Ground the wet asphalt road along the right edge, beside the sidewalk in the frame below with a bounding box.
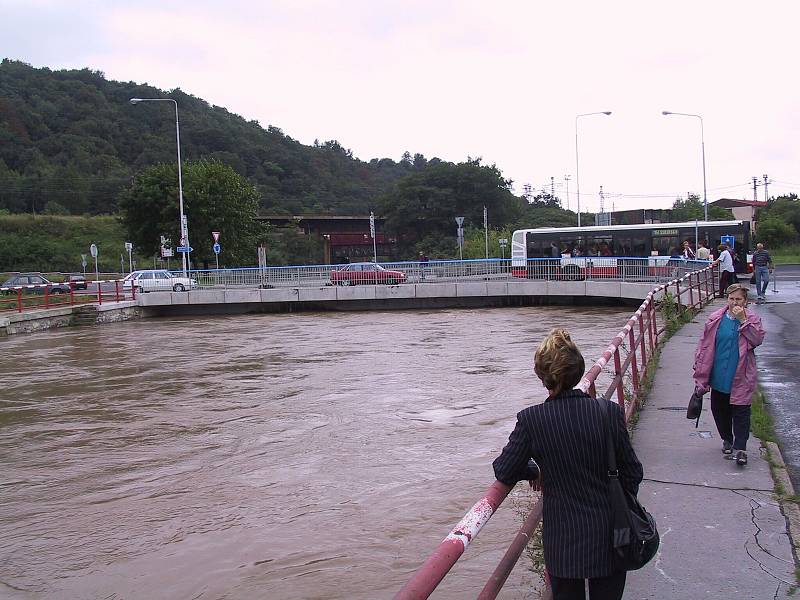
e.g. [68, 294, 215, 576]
[753, 265, 800, 490]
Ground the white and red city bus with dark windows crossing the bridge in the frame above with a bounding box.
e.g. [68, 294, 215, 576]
[511, 221, 750, 280]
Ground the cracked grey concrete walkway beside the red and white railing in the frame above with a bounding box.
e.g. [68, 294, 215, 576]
[624, 300, 800, 600]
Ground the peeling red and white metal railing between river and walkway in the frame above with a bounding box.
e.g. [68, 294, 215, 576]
[394, 266, 718, 600]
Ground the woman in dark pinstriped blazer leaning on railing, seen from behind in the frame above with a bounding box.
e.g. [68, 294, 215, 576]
[492, 329, 644, 600]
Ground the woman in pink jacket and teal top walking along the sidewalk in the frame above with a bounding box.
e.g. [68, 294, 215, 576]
[694, 283, 764, 465]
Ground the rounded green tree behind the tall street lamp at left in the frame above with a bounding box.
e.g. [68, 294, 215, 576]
[119, 160, 266, 266]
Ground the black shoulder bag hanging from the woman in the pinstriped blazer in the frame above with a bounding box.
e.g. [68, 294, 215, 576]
[599, 399, 661, 571]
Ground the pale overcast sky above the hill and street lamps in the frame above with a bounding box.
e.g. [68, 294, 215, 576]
[0, 0, 800, 211]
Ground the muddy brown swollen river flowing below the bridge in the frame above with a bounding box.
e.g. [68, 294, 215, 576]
[0, 307, 630, 600]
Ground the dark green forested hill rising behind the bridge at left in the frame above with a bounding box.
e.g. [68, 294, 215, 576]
[0, 59, 424, 214]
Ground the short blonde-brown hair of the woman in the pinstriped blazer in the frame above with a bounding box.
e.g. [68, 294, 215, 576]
[533, 329, 586, 396]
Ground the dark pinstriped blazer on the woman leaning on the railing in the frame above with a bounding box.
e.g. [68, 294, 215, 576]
[493, 390, 643, 579]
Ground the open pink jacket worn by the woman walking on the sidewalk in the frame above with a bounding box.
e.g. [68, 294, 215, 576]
[694, 306, 764, 405]
